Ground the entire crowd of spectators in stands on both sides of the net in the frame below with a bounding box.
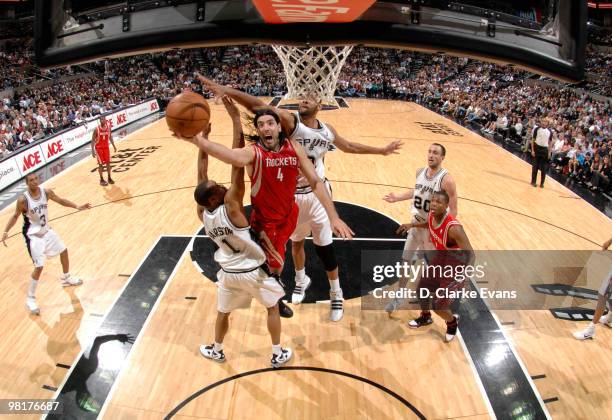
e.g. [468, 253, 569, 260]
[0, 42, 612, 196]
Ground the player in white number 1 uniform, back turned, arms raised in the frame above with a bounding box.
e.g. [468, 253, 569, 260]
[186, 97, 292, 367]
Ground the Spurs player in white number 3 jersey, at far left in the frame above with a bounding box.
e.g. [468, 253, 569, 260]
[2, 173, 91, 315]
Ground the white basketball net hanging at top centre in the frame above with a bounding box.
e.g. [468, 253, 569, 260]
[272, 45, 353, 105]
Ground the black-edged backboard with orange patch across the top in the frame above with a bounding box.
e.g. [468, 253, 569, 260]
[35, 0, 587, 82]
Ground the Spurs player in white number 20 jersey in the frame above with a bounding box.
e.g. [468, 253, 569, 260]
[383, 143, 457, 313]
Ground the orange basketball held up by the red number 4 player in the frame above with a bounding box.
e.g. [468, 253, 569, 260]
[166, 92, 210, 137]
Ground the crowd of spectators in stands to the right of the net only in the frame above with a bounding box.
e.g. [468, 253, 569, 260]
[336, 48, 612, 192]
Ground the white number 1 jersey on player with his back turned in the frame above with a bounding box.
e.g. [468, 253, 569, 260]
[202, 205, 266, 273]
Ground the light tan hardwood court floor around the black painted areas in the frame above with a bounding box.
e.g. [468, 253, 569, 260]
[0, 100, 612, 419]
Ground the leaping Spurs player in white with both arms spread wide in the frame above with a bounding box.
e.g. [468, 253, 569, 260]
[198, 76, 402, 321]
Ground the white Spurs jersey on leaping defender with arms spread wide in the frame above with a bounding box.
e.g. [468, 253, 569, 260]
[289, 114, 335, 189]
